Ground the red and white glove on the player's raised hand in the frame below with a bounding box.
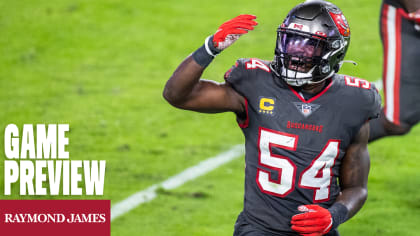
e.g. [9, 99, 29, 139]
[213, 15, 257, 50]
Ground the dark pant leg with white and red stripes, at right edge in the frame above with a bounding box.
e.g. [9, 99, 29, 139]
[381, 0, 420, 125]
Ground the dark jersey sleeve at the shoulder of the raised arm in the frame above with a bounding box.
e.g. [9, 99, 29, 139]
[224, 58, 249, 96]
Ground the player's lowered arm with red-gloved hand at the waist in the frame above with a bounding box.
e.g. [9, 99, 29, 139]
[291, 122, 370, 236]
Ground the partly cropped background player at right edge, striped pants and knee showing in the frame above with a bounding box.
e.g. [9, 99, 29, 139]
[369, 0, 420, 141]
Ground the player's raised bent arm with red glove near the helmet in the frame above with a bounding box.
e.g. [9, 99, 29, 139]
[163, 15, 257, 114]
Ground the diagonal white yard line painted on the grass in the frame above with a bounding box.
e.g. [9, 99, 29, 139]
[111, 144, 245, 221]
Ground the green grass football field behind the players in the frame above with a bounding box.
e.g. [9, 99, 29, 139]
[0, 0, 420, 236]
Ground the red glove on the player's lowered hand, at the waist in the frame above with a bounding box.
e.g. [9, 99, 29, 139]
[291, 205, 332, 236]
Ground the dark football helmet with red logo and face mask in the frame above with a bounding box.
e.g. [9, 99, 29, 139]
[271, 0, 350, 86]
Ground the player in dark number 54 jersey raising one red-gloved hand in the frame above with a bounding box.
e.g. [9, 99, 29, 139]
[163, 1, 380, 236]
